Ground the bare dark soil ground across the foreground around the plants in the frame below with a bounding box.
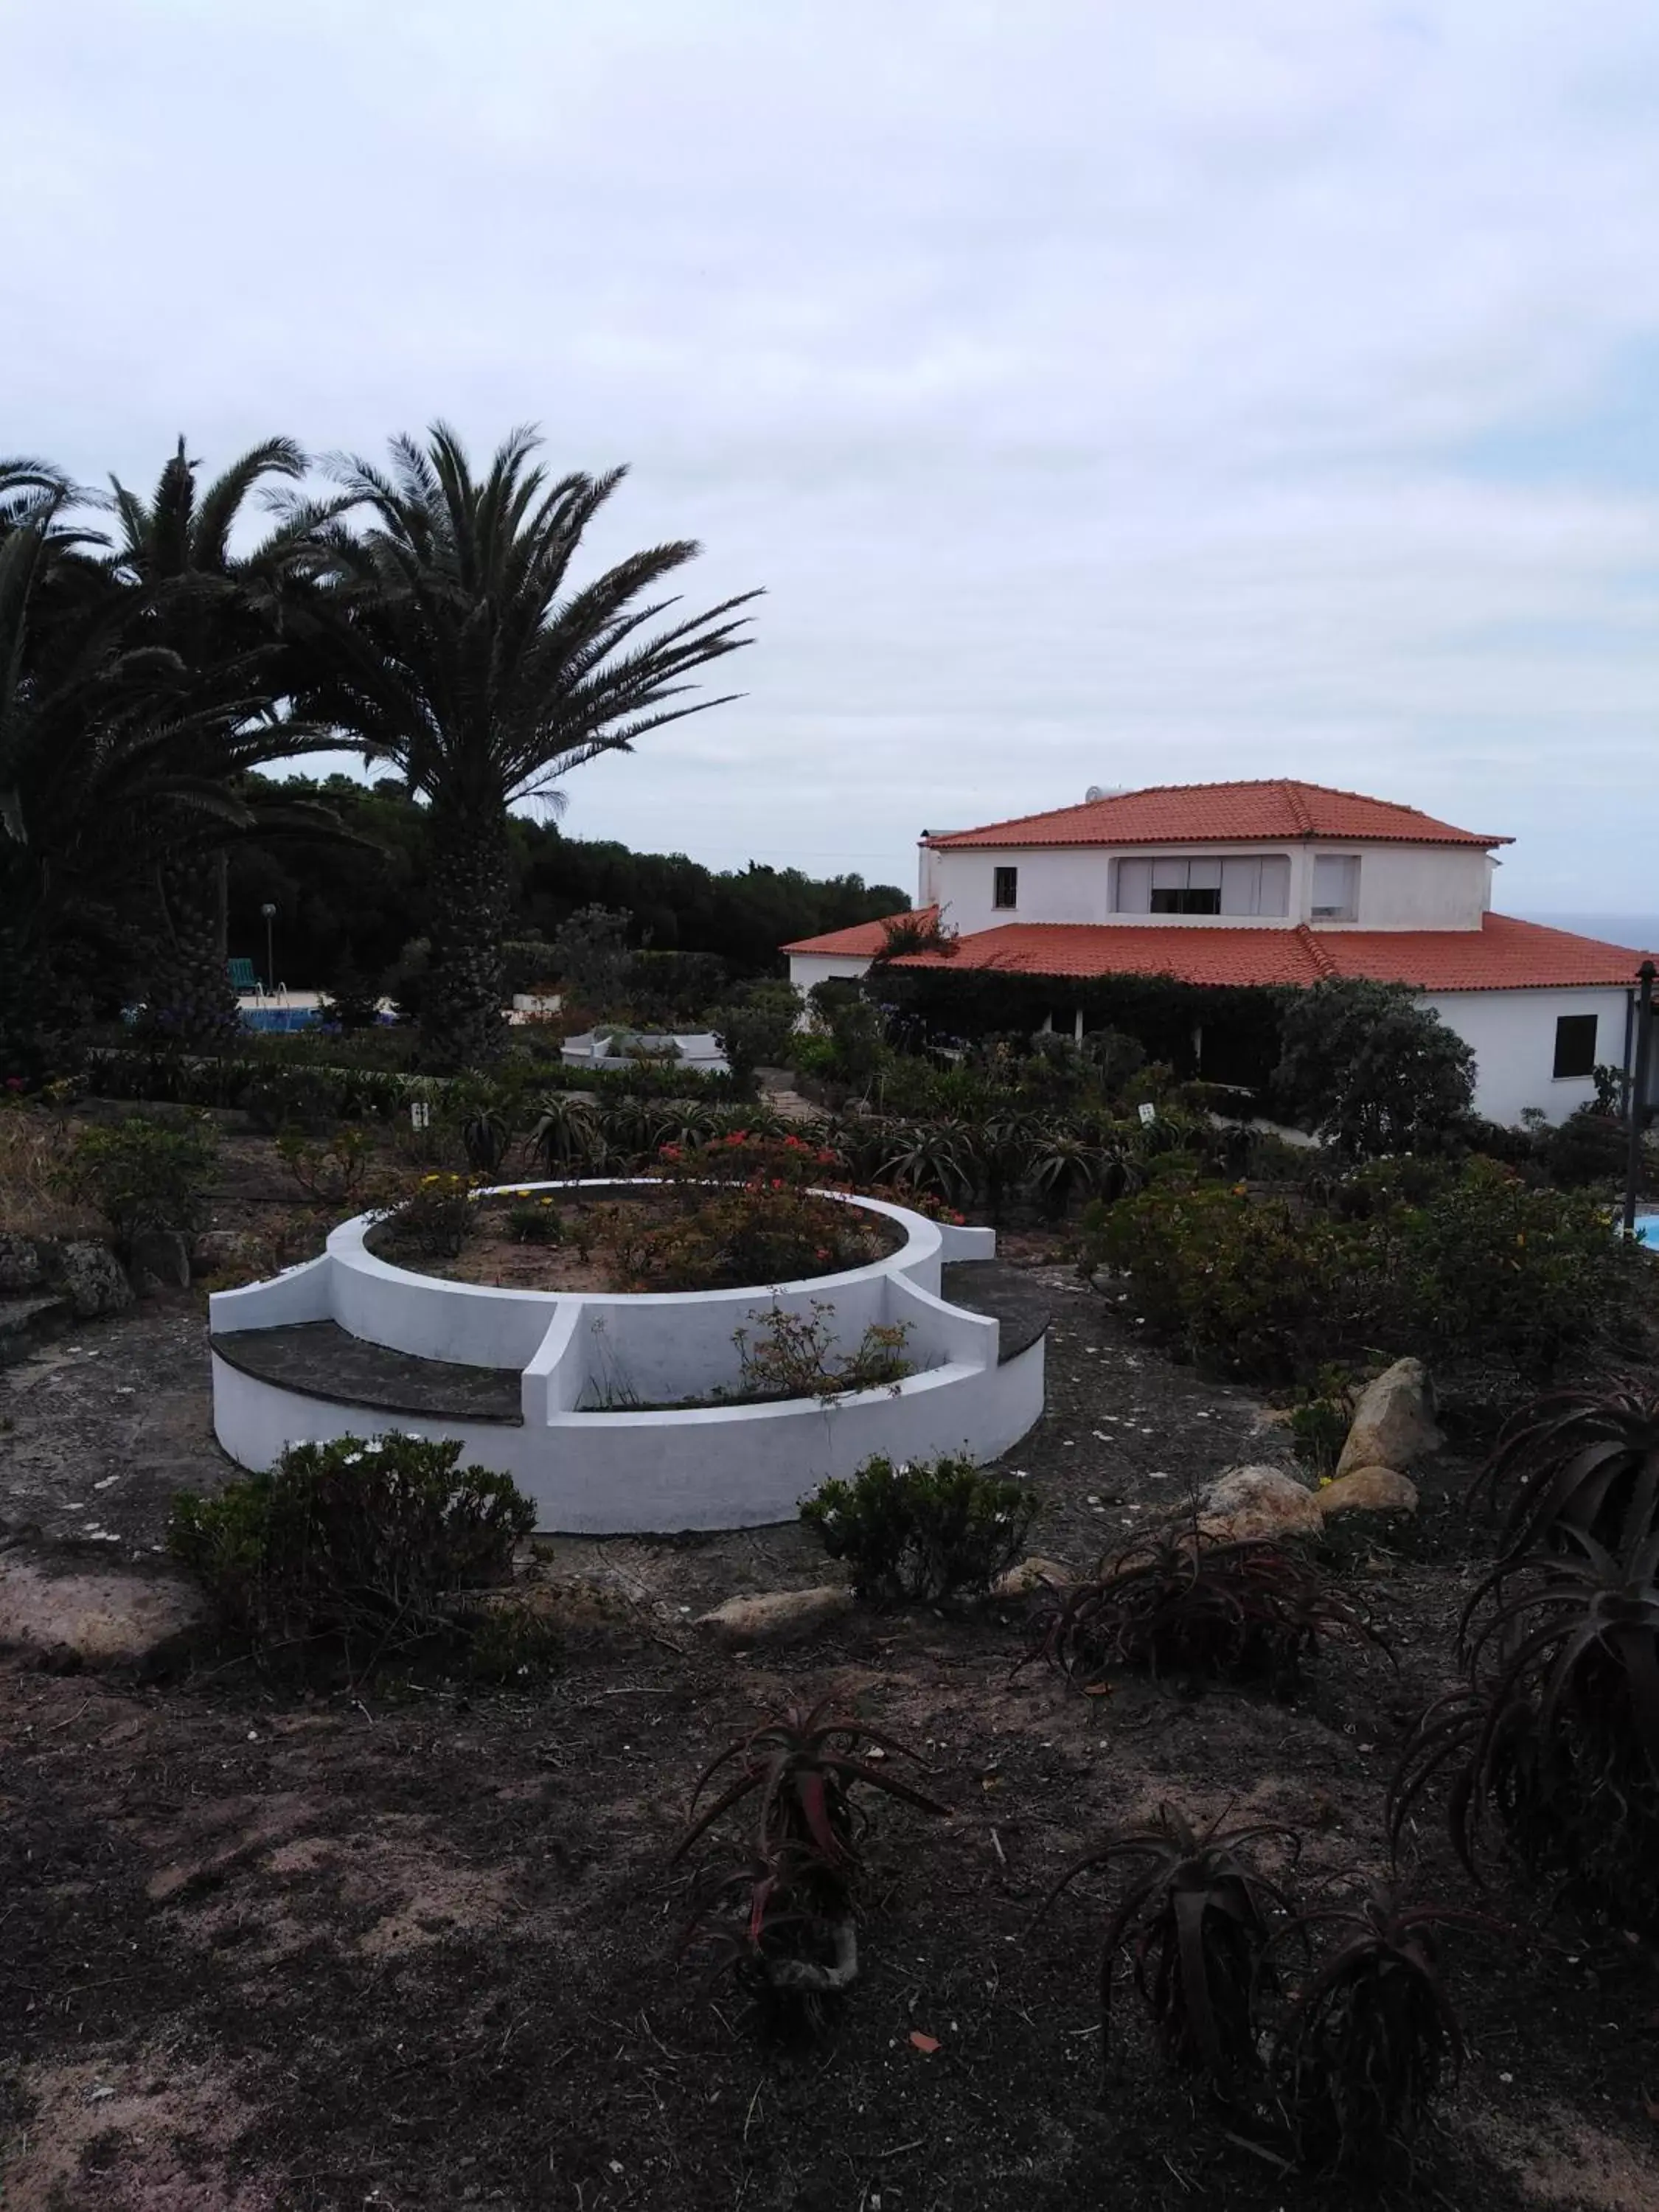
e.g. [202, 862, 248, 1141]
[0, 1239, 1659, 2212]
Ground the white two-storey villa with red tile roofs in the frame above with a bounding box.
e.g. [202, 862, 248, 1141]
[783, 781, 1652, 1124]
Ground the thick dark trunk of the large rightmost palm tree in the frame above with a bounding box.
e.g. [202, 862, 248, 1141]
[420, 799, 511, 1071]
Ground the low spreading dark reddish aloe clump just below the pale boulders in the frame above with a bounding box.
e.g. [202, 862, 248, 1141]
[1033, 1528, 1385, 1688]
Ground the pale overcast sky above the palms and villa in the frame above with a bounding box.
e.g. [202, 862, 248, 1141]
[0, 0, 1659, 914]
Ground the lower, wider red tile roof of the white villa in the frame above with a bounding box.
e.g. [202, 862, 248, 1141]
[876, 914, 1646, 991]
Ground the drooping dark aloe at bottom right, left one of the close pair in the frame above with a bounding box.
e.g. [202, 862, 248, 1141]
[1042, 1807, 1296, 2099]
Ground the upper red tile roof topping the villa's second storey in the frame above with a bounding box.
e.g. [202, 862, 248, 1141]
[922, 779, 1513, 852]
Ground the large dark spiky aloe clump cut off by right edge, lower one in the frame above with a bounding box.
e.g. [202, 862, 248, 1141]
[1389, 1522, 1659, 1935]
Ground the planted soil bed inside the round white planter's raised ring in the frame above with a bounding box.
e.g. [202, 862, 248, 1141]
[367, 1183, 905, 1294]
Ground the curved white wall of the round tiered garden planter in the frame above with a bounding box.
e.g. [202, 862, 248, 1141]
[210, 1183, 1044, 1535]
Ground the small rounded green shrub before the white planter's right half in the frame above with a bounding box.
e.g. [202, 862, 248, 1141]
[801, 1455, 1037, 1599]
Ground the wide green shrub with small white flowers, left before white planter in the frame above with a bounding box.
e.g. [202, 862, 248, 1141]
[168, 1431, 535, 1657]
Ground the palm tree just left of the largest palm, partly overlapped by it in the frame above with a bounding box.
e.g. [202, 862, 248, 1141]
[108, 438, 334, 1044]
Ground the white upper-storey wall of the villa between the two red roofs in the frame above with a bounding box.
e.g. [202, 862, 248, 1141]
[938, 843, 1491, 936]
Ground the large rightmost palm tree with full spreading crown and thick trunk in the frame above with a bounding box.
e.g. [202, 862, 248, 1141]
[305, 422, 759, 1066]
